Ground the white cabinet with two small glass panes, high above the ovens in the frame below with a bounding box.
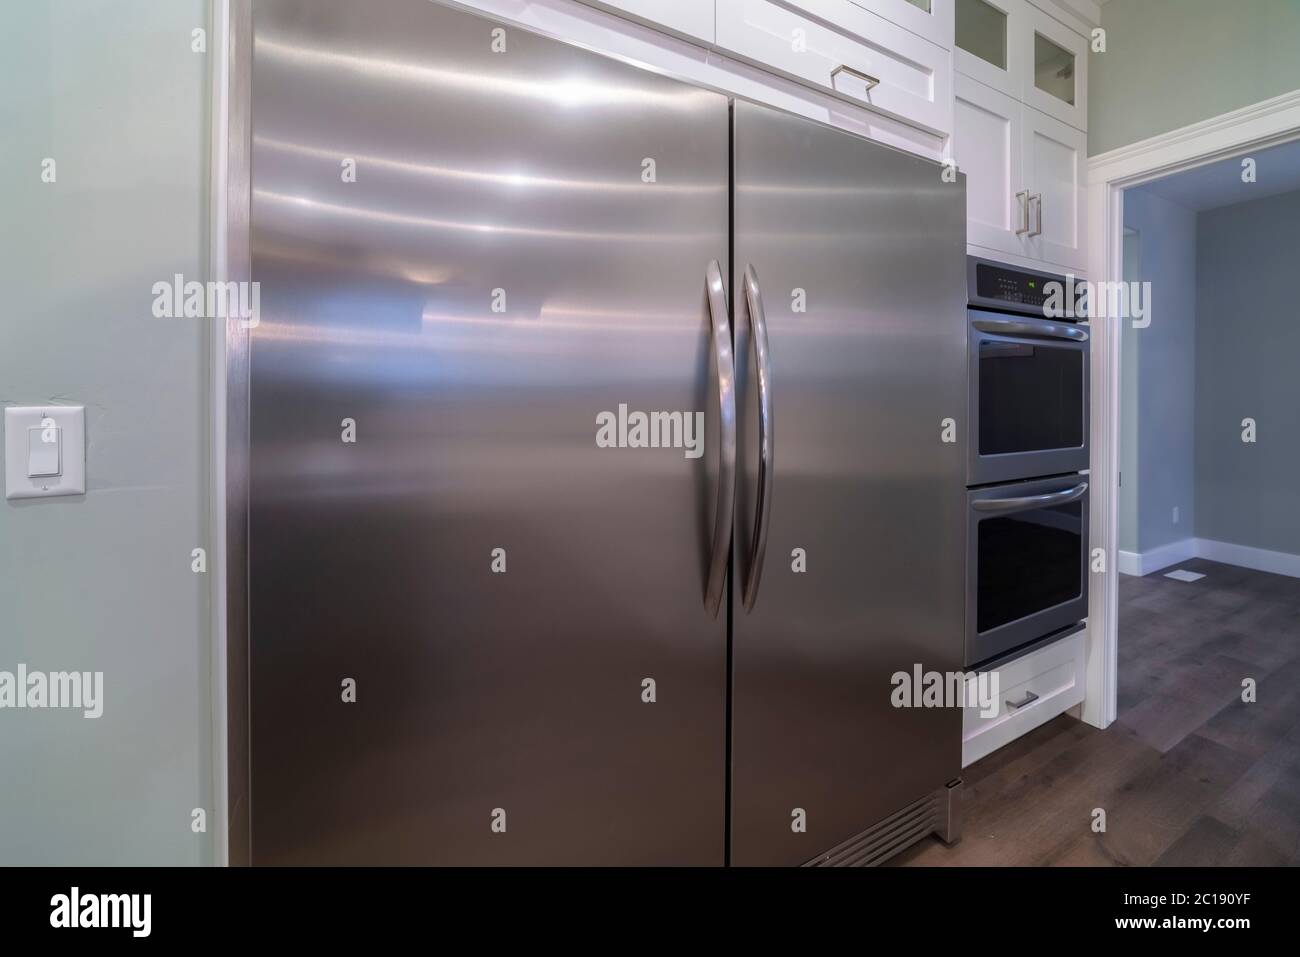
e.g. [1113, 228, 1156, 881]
[953, 0, 1088, 130]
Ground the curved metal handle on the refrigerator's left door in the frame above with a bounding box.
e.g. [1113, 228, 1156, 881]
[705, 259, 736, 618]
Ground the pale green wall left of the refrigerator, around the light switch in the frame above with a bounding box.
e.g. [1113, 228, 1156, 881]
[0, 0, 213, 865]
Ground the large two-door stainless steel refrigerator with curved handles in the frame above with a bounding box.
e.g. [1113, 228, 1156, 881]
[248, 0, 966, 865]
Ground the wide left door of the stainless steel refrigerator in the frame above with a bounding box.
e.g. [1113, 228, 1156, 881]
[250, 0, 729, 865]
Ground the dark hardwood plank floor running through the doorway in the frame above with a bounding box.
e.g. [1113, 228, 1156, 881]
[893, 559, 1300, 865]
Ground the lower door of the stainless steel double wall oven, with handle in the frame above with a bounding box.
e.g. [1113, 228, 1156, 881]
[966, 475, 1088, 666]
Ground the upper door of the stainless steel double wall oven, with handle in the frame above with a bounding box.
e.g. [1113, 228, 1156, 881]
[966, 309, 1088, 485]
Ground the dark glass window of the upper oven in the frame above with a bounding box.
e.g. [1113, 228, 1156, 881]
[979, 341, 1083, 455]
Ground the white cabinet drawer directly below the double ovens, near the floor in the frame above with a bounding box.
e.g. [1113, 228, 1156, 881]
[962, 632, 1086, 767]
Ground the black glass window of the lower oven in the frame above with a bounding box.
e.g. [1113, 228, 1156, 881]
[975, 502, 1083, 633]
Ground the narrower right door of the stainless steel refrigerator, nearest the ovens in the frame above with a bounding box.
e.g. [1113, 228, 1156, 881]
[731, 100, 966, 865]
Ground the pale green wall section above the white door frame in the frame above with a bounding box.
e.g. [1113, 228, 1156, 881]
[1088, 0, 1300, 156]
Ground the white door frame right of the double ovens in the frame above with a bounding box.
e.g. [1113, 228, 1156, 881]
[1080, 90, 1300, 728]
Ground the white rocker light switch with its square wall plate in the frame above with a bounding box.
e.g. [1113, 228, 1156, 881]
[4, 406, 86, 499]
